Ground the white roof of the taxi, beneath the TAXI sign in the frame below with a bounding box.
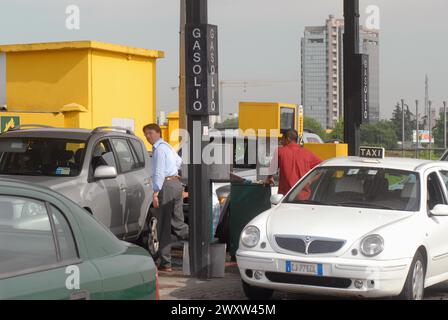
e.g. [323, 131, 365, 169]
[322, 157, 448, 172]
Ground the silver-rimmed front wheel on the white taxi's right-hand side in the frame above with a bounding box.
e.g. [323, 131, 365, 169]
[399, 252, 426, 300]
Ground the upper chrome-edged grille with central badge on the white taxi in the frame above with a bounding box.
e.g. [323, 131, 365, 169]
[275, 236, 345, 254]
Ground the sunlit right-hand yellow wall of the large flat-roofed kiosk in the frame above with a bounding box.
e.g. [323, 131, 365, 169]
[92, 50, 156, 148]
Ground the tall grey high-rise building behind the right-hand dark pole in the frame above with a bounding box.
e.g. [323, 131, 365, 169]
[301, 16, 379, 128]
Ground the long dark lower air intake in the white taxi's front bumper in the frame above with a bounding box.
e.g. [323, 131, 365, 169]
[265, 272, 352, 289]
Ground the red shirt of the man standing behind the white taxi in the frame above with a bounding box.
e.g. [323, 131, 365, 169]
[277, 143, 322, 195]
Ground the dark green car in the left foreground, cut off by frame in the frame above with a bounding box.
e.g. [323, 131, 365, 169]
[0, 180, 158, 300]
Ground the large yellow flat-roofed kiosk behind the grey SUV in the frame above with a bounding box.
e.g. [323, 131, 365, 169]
[0, 41, 164, 148]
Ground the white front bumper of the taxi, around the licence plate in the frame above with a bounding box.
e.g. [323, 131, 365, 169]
[236, 250, 412, 298]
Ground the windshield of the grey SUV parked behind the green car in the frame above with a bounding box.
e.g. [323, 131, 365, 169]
[0, 138, 86, 177]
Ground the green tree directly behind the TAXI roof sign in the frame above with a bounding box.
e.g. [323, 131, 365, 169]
[361, 120, 397, 149]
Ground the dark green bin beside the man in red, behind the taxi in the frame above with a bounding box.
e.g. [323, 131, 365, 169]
[229, 183, 271, 256]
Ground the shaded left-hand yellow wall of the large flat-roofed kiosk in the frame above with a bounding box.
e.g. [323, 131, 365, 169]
[6, 50, 90, 112]
